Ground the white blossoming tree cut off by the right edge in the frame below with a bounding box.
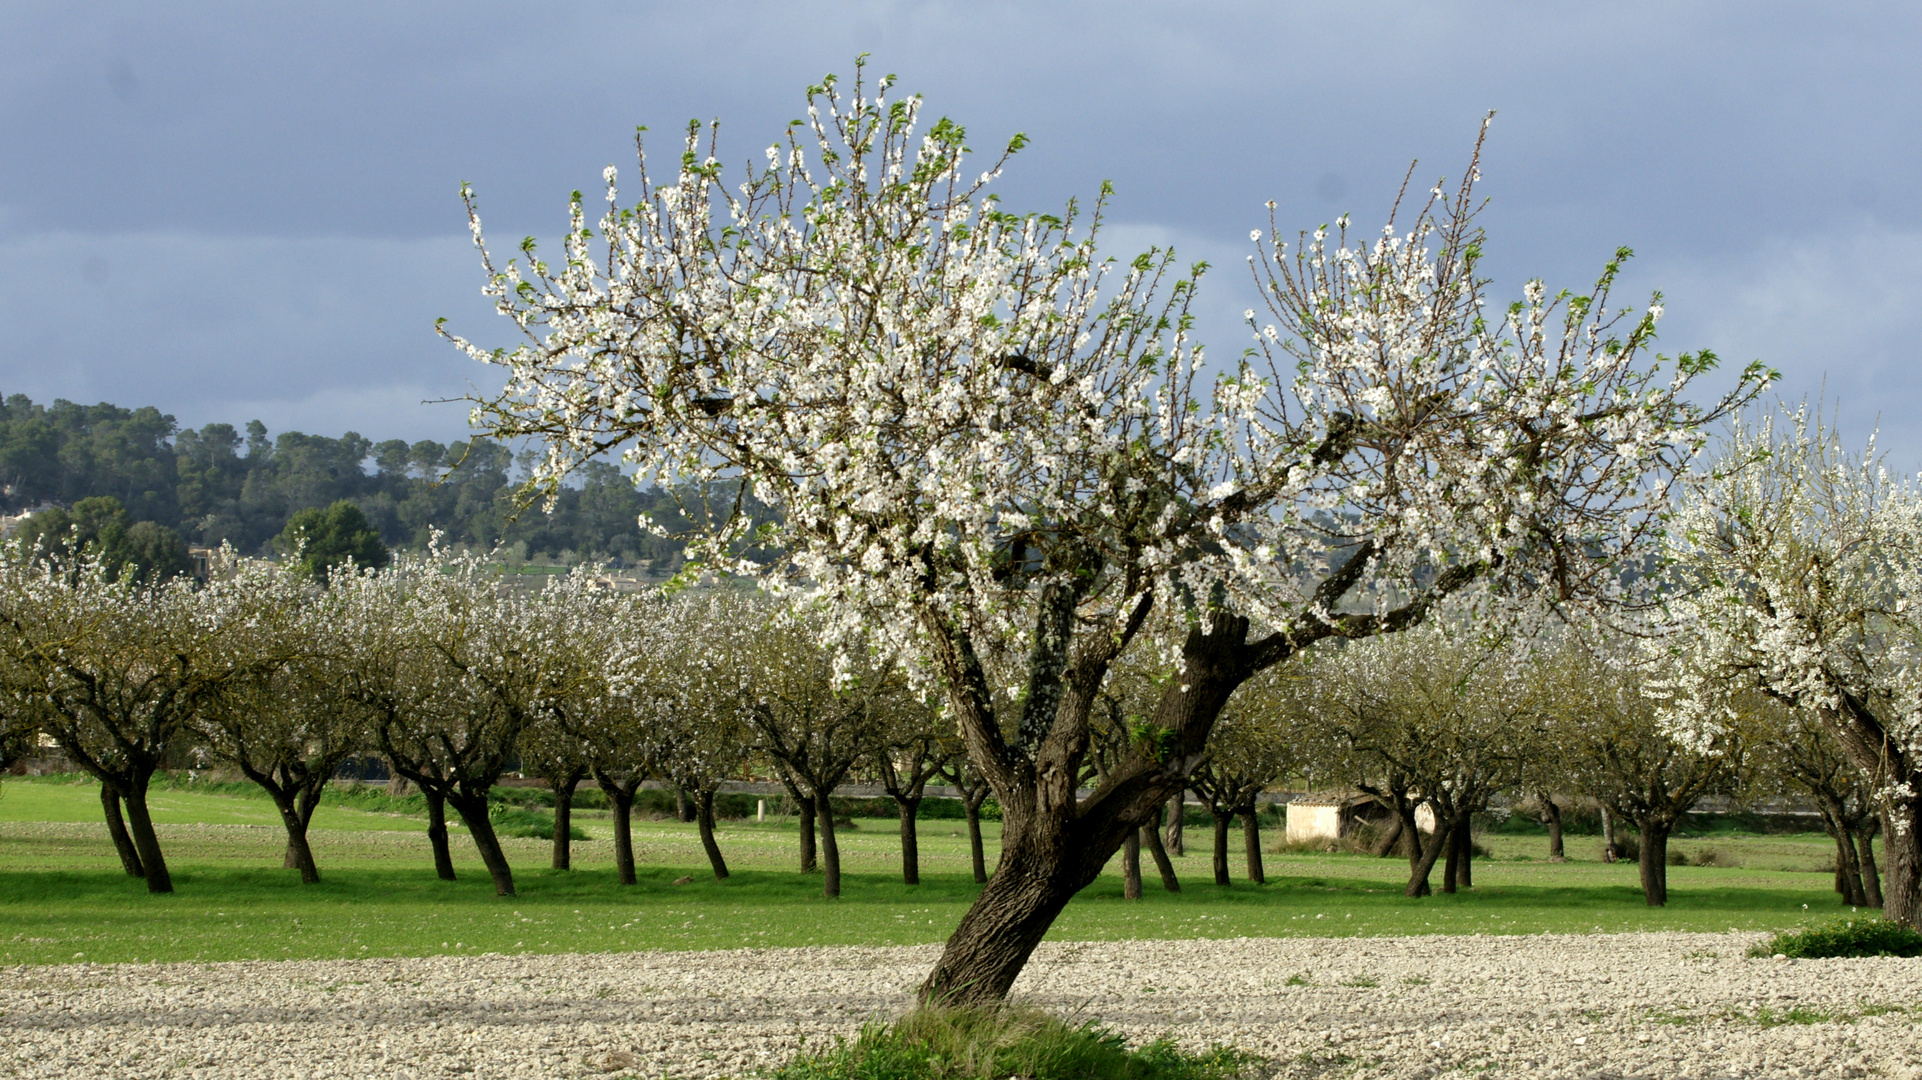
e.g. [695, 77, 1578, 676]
[1659, 407, 1922, 926]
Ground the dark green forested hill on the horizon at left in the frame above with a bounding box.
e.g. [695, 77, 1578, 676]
[0, 394, 699, 571]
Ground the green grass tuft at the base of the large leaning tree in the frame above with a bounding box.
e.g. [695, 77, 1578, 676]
[771, 1005, 1261, 1080]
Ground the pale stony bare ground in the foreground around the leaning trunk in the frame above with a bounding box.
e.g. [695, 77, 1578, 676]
[0, 934, 1922, 1080]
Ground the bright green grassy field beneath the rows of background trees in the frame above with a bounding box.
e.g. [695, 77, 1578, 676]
[0, 768, 1860, 963]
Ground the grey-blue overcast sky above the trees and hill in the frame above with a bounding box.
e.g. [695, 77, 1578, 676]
[0, 0, 1922, 469]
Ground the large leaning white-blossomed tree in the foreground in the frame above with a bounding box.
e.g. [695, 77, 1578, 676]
[450, 62, 1762, 1001]
